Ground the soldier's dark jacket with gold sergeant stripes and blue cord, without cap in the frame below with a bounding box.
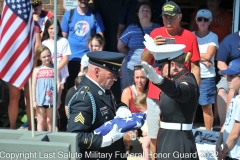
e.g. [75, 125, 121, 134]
[68, 76, 125, 160]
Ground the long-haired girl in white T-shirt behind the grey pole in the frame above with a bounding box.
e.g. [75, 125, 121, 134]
[42, 18, 71, 108]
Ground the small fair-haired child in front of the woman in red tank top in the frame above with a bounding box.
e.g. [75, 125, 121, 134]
[134, 93, 151, 160]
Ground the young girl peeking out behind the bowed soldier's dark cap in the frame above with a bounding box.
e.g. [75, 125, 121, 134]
[78, 33, 105, 76]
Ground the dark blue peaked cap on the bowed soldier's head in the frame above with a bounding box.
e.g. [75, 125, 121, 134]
[87, 51, 125, 77]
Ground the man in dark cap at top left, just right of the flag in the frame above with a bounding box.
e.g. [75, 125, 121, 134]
[31, 0, 53, 32]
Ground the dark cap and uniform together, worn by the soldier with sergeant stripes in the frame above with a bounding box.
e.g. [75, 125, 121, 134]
[67, 51, 126, 160]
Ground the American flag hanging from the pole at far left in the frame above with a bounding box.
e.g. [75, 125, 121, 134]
[0, 0, 35, 89]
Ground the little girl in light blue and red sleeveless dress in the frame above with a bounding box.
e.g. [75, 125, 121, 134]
[32, 46, 57, 132]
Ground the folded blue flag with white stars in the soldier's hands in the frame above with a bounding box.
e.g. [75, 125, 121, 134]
[94, 113, 146, 136]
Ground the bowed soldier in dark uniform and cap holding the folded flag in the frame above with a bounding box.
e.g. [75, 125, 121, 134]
[67, 51, 132, 160]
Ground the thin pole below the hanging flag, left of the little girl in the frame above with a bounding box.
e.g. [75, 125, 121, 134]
[28, 76, 35, 137]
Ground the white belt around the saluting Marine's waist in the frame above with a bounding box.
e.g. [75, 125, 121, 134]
[160, 121, 193, 131]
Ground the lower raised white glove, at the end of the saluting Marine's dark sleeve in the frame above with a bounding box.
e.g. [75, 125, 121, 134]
[141, 61, 163, 84]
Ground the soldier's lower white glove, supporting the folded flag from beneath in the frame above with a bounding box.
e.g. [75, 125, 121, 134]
[101, 124, 124, 148]
